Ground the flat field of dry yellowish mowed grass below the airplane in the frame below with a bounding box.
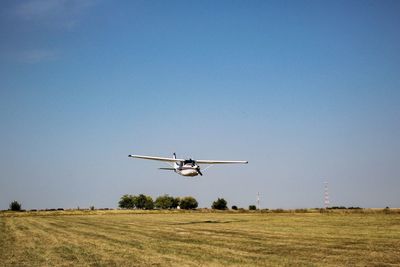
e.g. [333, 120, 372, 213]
[0, 211, 400, 266]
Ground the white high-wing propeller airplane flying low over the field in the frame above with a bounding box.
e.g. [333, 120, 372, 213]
[128, 153, 248, 176]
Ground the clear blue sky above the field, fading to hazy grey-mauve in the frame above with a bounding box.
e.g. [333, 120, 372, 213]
[0, 0, 400, 209]
